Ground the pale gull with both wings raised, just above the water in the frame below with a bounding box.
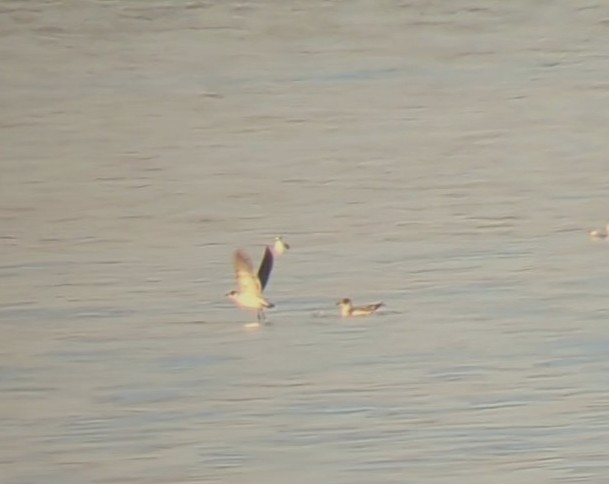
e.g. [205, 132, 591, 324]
[227, 246, 275, 323]
